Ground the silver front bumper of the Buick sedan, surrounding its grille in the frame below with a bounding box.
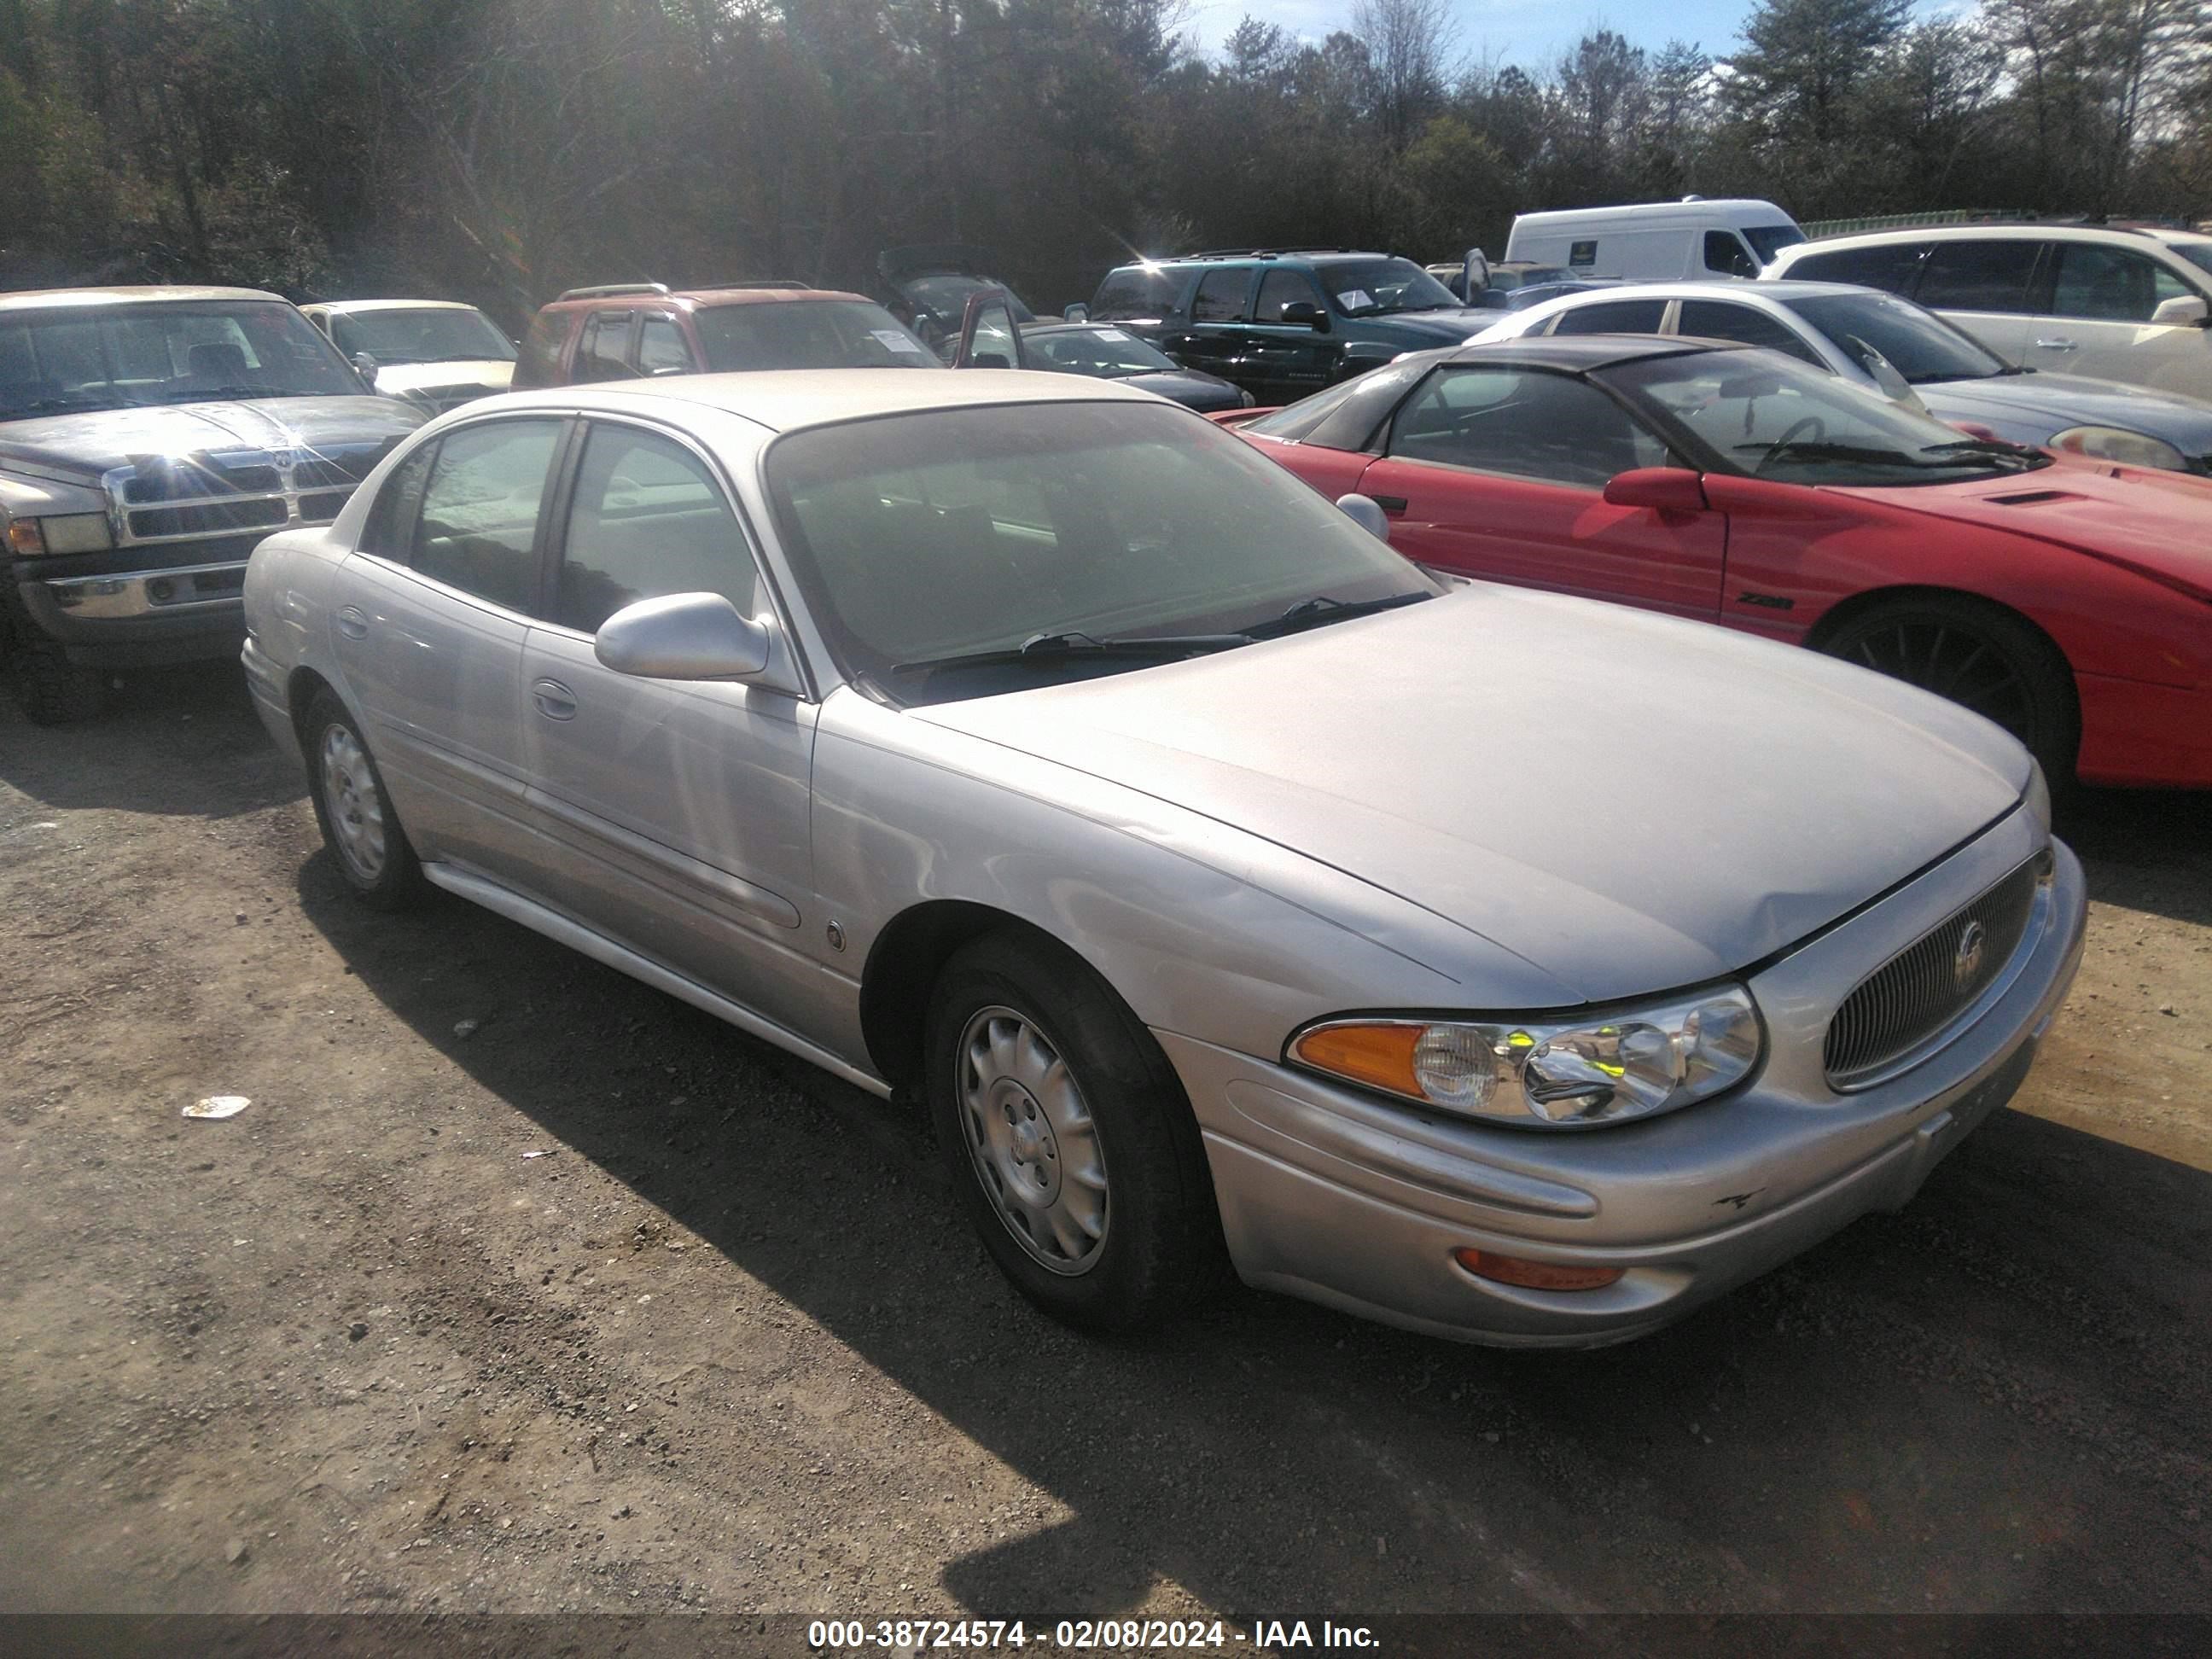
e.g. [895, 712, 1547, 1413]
[1157, 812, 2088, 1348]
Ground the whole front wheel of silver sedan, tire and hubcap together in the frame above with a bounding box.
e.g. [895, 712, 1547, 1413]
[927, 935, 1221, 1331]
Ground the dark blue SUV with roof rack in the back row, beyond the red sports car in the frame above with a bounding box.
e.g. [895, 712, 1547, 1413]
[1091, 247, 1498, 403]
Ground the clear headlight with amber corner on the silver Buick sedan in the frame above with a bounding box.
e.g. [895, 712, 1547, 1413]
[1288, 987, 1765, 1128]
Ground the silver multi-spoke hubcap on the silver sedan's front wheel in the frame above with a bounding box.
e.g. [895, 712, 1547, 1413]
[958, 1009, 1106, 1277]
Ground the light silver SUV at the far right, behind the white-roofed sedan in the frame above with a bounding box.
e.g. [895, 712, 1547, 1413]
[1765, 225, 2212, 399]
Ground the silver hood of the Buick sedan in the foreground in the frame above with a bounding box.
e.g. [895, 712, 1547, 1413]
[911, 582, 2029, 1002]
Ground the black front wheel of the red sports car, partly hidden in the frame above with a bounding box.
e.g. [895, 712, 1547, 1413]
[1820, 593, 2081, 789]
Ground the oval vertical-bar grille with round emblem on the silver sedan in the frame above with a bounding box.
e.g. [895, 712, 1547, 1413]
[1823, 854, 2051, 1088]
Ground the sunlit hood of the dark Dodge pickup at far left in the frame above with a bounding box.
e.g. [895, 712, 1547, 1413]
[0, 399, 427, 482]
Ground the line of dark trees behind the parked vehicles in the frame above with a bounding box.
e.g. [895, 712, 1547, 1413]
[0, 0, 2212, 328]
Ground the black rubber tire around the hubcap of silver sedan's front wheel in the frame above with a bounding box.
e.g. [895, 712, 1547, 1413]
[924, 934, 1225, 1331]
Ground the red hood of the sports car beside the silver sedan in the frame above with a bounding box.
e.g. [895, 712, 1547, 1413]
[1838, 460, 2212, 599]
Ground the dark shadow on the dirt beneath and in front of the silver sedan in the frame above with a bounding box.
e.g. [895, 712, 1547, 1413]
[299, 845, 2212, 1617]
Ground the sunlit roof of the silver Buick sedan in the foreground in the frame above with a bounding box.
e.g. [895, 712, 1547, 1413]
[467, 370, 1174, 431]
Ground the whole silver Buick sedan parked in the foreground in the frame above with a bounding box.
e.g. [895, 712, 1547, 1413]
[246, 370, 2084, 1345]
